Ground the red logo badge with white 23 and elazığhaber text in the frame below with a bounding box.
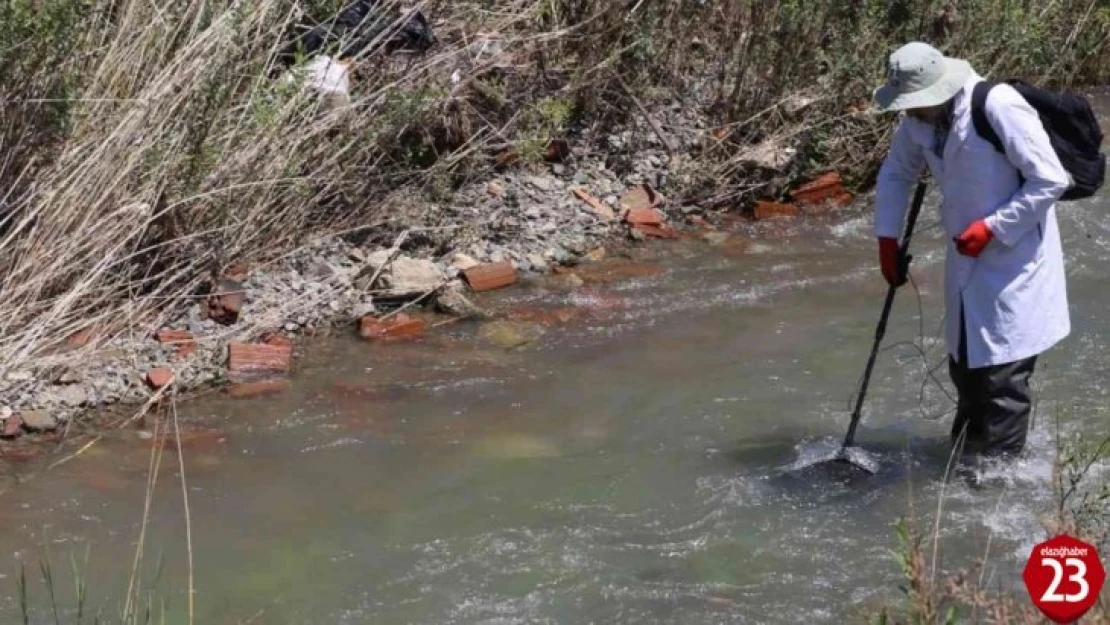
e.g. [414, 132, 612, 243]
[1021, 534, 1107, 623]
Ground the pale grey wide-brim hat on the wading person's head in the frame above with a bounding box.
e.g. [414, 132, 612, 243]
[875, 41, 971, 111]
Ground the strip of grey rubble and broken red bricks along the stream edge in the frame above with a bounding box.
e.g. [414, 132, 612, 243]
[0, 130, 852, 458]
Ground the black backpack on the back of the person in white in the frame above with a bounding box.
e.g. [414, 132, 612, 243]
[971, 79, 1107, 201]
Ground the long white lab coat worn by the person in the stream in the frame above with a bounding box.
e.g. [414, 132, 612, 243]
[875, 74, 1071, 367]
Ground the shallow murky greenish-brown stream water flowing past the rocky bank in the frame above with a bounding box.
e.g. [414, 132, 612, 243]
[0, 95, 1110, 624]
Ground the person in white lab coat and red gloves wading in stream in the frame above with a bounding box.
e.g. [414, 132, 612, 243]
[875, 42, 1071, 477]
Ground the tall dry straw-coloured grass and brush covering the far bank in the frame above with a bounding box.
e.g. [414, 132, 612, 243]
[0, 0, 1110, 375]
